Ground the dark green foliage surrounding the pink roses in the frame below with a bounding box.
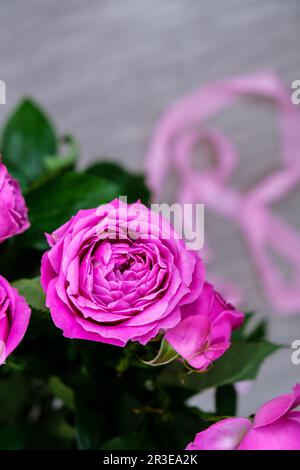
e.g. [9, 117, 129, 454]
[0, 100, 277, 450]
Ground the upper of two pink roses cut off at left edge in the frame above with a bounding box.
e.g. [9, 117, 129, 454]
[0, 162, 30, 243]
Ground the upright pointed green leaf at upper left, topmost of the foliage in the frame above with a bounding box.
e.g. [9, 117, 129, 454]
[1, 99, 57, 190]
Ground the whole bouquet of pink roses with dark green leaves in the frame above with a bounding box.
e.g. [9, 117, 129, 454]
[0, 100, 294, 450]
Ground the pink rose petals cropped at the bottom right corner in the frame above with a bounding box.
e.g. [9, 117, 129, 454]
[187, 385, 300, 450]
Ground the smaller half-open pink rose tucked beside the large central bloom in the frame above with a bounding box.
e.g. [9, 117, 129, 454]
[165, 282, 244, 370]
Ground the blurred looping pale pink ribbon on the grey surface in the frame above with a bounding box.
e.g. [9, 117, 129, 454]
[146, 72, 300, 314]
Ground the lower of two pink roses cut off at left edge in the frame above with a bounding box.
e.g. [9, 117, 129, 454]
[0, 276, 30, 364]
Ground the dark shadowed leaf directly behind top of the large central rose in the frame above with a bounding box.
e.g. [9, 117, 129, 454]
[86, 161, 150, 205]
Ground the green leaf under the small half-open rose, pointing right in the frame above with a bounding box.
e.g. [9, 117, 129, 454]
[160, 341, 280, 392]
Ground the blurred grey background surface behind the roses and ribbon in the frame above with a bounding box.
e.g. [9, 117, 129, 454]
[0, 0, 300, 414]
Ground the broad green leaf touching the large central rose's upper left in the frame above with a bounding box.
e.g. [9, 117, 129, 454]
[21, 172, 119, 250]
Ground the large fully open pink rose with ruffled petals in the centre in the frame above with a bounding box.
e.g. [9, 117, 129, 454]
[41, 199, 204, 346]
